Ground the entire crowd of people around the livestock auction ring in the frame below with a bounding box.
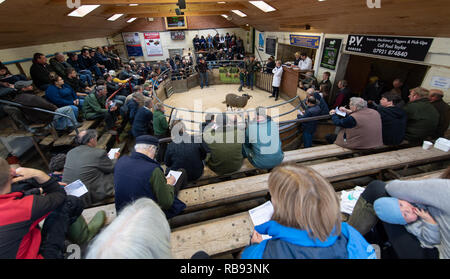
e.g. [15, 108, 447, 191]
[0, 47, 450, 259]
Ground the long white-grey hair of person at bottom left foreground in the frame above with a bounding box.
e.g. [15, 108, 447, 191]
[86, 198, 172, 259]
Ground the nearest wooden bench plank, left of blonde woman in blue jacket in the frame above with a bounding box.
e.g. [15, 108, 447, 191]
[171, 168, 444, 259]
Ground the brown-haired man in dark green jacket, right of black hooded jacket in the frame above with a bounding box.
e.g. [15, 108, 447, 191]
[404, 87, 439, 144]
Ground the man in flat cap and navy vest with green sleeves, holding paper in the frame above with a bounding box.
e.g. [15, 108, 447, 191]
[114, 135, 187, 219]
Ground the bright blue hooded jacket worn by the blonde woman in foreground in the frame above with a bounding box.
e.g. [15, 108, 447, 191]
[242, 220, 376, 259]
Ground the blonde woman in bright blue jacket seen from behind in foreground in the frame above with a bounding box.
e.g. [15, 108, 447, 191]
[242, 165, 376, 259]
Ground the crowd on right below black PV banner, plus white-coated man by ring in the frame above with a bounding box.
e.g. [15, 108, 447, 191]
[292, 71, 450, 149]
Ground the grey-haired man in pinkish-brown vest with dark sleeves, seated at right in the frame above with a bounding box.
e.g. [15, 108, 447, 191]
[330, 97, 383, 149]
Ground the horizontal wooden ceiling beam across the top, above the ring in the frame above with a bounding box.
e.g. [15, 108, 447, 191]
[103, 3, 245, 14]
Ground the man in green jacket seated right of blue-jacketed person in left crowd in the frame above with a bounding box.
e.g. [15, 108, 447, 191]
[83, 85, 118, 134]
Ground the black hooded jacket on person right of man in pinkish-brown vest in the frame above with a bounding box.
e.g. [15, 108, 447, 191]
[377, 106, 408, 145]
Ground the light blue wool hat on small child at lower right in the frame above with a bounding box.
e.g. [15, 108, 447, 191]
[373, 197, 407, 225]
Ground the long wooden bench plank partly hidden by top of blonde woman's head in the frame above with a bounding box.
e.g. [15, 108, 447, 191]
[83, 147, 450, 229]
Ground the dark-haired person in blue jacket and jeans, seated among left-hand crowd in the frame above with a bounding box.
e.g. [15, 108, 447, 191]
[45, 75, 84, 117]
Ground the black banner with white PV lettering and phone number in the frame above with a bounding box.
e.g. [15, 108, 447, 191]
[345, 35, 433, 61]
